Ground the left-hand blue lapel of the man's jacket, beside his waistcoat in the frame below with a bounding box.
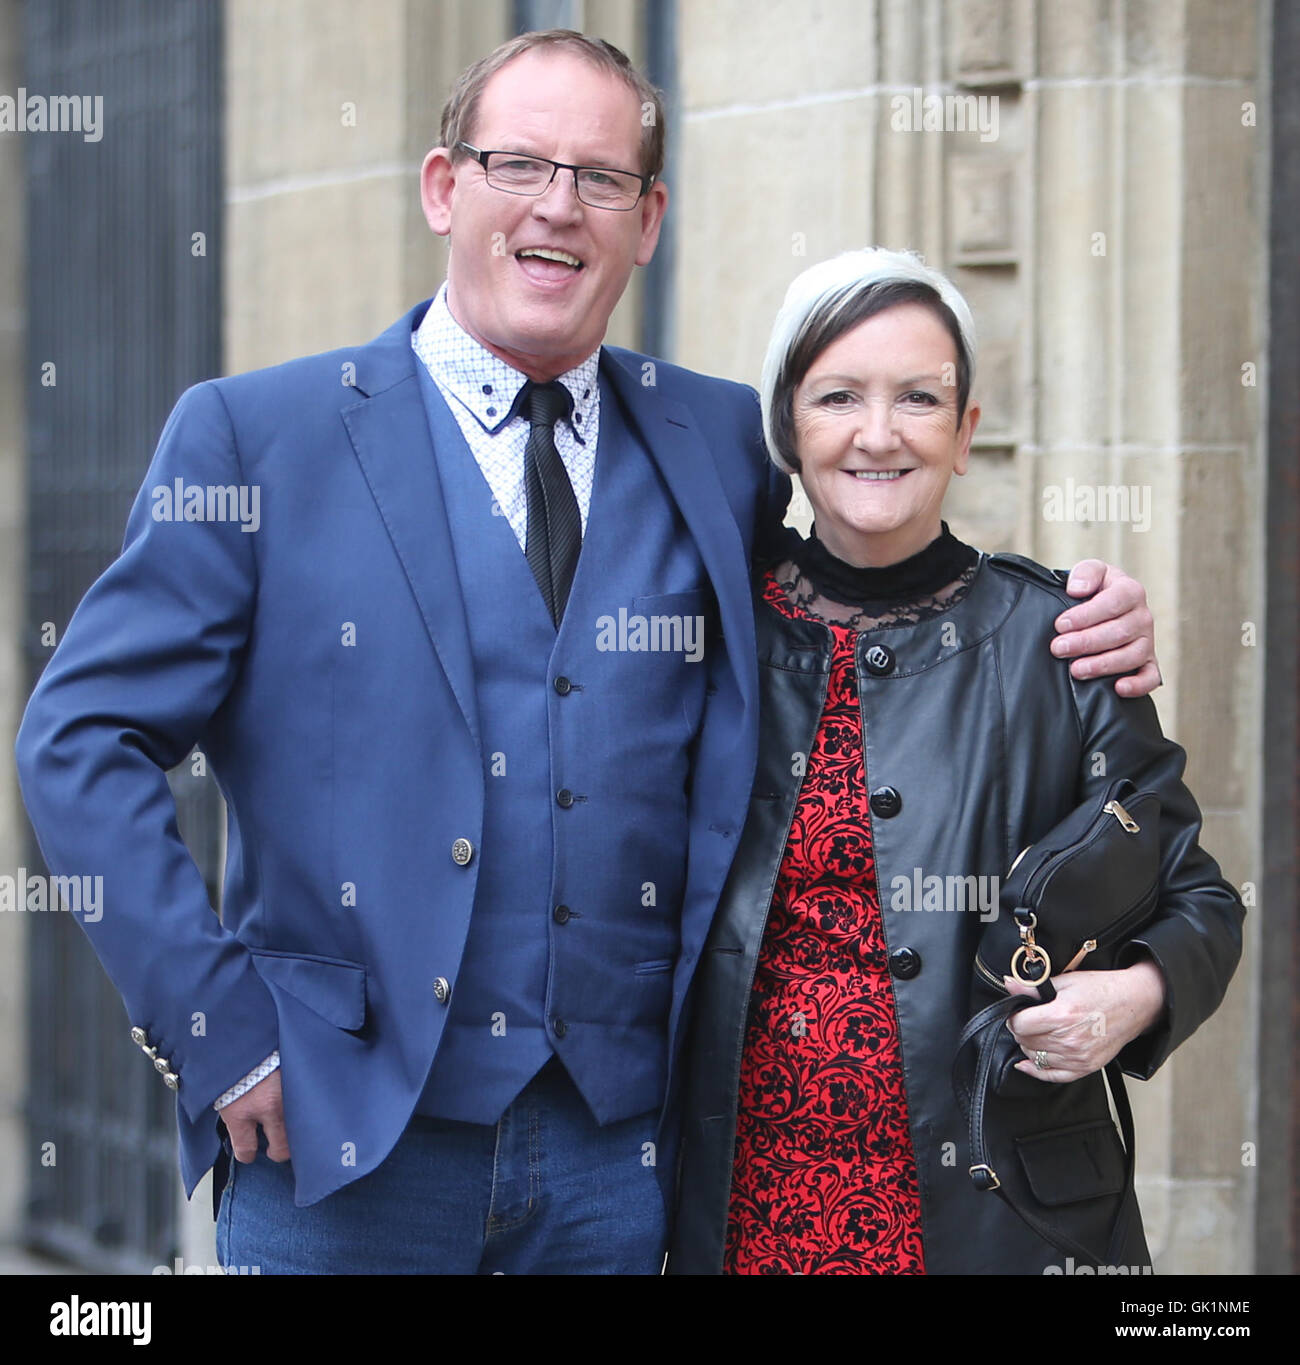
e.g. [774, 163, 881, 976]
[341, 300, 481, 744]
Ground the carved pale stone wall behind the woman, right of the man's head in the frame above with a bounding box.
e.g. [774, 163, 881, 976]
[672, 0, 1269, 1272]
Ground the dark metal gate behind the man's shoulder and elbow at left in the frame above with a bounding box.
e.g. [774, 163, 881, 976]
[23, 0, 223, 1271]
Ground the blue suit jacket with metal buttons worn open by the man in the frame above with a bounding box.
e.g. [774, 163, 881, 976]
[16, 300, 789, 1205]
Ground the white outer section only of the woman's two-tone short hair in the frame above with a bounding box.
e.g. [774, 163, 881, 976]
[759, 247, 975, 474]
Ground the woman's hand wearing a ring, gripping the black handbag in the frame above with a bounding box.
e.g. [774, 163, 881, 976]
[1002, 961, 1165, 1082]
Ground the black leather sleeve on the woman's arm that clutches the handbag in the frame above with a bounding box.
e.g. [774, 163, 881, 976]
[1071, 668, 1245, 1080]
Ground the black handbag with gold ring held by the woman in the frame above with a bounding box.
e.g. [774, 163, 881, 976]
[953, 779, 1161, 1265]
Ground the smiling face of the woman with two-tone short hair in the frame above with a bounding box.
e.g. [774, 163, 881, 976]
[795, 303, 979, 565]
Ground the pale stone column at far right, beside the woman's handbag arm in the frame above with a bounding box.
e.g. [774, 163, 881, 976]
[1019, 0, 1267, 1274]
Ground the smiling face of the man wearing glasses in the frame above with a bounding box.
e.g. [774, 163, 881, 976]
[421, 52, 668, 381]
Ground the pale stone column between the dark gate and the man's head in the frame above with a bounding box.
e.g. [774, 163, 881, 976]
[224, 0, 511, 373]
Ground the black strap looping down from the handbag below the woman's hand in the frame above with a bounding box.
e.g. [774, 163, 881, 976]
[953, 992, 1135, 1264]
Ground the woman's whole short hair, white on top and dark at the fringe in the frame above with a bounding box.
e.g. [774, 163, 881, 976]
[759, 247, 975, 474]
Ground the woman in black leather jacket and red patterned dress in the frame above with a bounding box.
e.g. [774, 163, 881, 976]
[669, 250, 1243, 1274]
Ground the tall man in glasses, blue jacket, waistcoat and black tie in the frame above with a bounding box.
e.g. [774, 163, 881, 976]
[18, 33, 1155, 1274]
